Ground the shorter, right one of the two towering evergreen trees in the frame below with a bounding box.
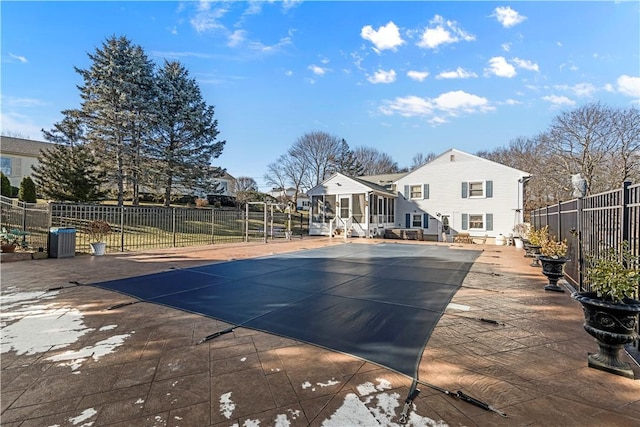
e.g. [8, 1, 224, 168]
[146, 61, 225, 206]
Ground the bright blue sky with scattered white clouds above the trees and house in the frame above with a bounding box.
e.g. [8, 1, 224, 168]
[0, 0, 640, 191]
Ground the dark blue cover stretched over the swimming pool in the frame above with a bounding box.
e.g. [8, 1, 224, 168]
[94, 243, 480, 378]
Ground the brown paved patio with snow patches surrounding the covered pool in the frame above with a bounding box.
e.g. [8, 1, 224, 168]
[0, 238, 640, 427]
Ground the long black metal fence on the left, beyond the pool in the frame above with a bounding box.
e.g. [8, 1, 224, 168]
[0, 197, 309, 253]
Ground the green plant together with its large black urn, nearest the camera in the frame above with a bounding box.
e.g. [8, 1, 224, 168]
[571, 242, 640, 378]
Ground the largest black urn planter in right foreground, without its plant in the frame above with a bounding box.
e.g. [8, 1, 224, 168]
[571, 292, 640, 378]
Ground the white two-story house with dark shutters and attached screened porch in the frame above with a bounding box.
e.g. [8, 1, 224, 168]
[309, 149, 529, 241]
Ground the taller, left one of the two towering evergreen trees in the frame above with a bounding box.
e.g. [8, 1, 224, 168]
[76, 36, 154, 205]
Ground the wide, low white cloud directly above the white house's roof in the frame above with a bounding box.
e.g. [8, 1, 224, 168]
[380, 90, 494, 124]
